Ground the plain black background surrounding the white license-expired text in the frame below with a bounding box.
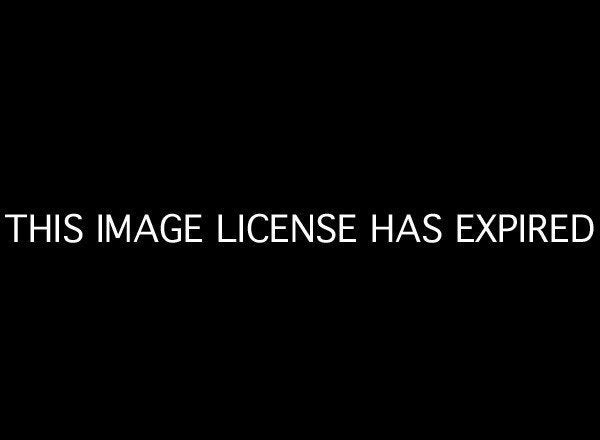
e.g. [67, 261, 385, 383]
[1, 5, 598, 433]
